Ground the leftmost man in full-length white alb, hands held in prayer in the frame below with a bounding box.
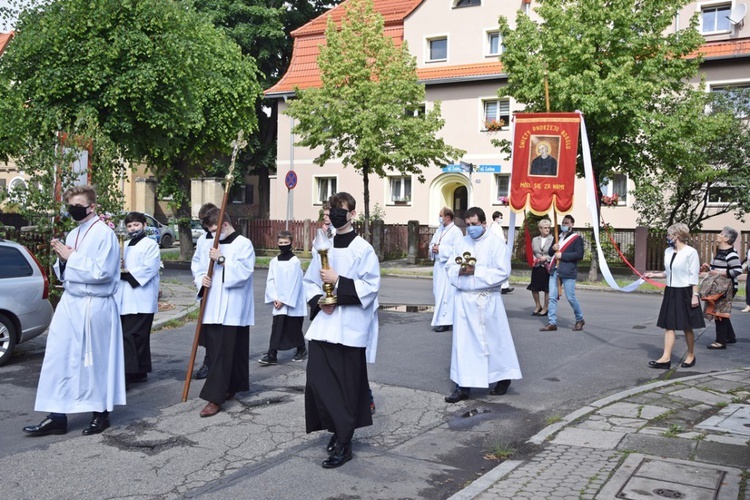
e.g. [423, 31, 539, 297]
[23, 186, 125, 436]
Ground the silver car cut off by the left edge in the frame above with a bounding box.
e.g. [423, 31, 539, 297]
[0, 238, 52, 366]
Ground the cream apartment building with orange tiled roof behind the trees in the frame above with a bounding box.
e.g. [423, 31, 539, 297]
[266, 0, 750, 229]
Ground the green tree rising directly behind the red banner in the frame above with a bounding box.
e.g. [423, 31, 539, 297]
[497, 0, 703, 280]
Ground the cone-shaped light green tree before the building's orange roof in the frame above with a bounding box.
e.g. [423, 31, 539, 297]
[287, 0, 464, 235]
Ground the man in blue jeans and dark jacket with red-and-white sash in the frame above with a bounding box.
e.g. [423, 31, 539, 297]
[539, 215, 586, 332]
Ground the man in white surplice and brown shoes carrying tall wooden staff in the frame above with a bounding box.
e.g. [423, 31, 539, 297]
[196, 208, 255, 417]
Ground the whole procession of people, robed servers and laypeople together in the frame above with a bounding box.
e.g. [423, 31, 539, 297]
[23, 186, 741, 468]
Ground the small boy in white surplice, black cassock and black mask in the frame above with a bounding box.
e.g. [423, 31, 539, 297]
[258, 231, 307, 366]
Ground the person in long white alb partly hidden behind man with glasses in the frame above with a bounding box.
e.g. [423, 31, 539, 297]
[430, 207, 464, 332]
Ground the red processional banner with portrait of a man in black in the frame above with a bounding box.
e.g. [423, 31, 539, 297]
[510, 113, 581, 215]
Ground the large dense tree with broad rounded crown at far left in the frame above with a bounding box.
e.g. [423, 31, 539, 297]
[0, 0, 260, 258]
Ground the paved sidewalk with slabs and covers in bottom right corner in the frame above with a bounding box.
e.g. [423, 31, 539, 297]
[154, 282, 750, 499]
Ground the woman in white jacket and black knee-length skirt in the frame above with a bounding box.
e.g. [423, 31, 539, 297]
[644, 223, 706, 370]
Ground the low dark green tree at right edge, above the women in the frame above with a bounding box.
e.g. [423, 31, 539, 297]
[633, 88, 750, 229]
